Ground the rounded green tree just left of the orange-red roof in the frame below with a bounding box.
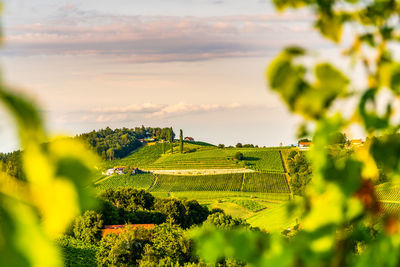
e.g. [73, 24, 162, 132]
[73, 210, 103, 243]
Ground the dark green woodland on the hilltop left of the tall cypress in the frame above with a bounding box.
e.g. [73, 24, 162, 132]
[77, 126, 175, 160]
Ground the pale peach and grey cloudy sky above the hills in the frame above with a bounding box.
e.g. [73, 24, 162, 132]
[0, 0, 338, 152]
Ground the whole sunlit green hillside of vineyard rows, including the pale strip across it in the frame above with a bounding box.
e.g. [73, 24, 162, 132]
[95, 142, 295, 230]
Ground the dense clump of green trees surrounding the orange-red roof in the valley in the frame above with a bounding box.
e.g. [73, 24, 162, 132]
[62, 188, 258, 266]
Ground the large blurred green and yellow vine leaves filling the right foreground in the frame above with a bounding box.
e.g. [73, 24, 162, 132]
[197, 0, 400, 266]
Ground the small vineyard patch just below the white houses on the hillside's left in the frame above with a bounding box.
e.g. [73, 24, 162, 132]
[95, 173, 154, 191]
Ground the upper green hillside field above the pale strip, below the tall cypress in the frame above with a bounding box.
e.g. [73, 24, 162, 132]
[102, 142, 285, 172]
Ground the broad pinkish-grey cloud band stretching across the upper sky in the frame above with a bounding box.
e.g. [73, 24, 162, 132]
[1, 5, 326, 63]
